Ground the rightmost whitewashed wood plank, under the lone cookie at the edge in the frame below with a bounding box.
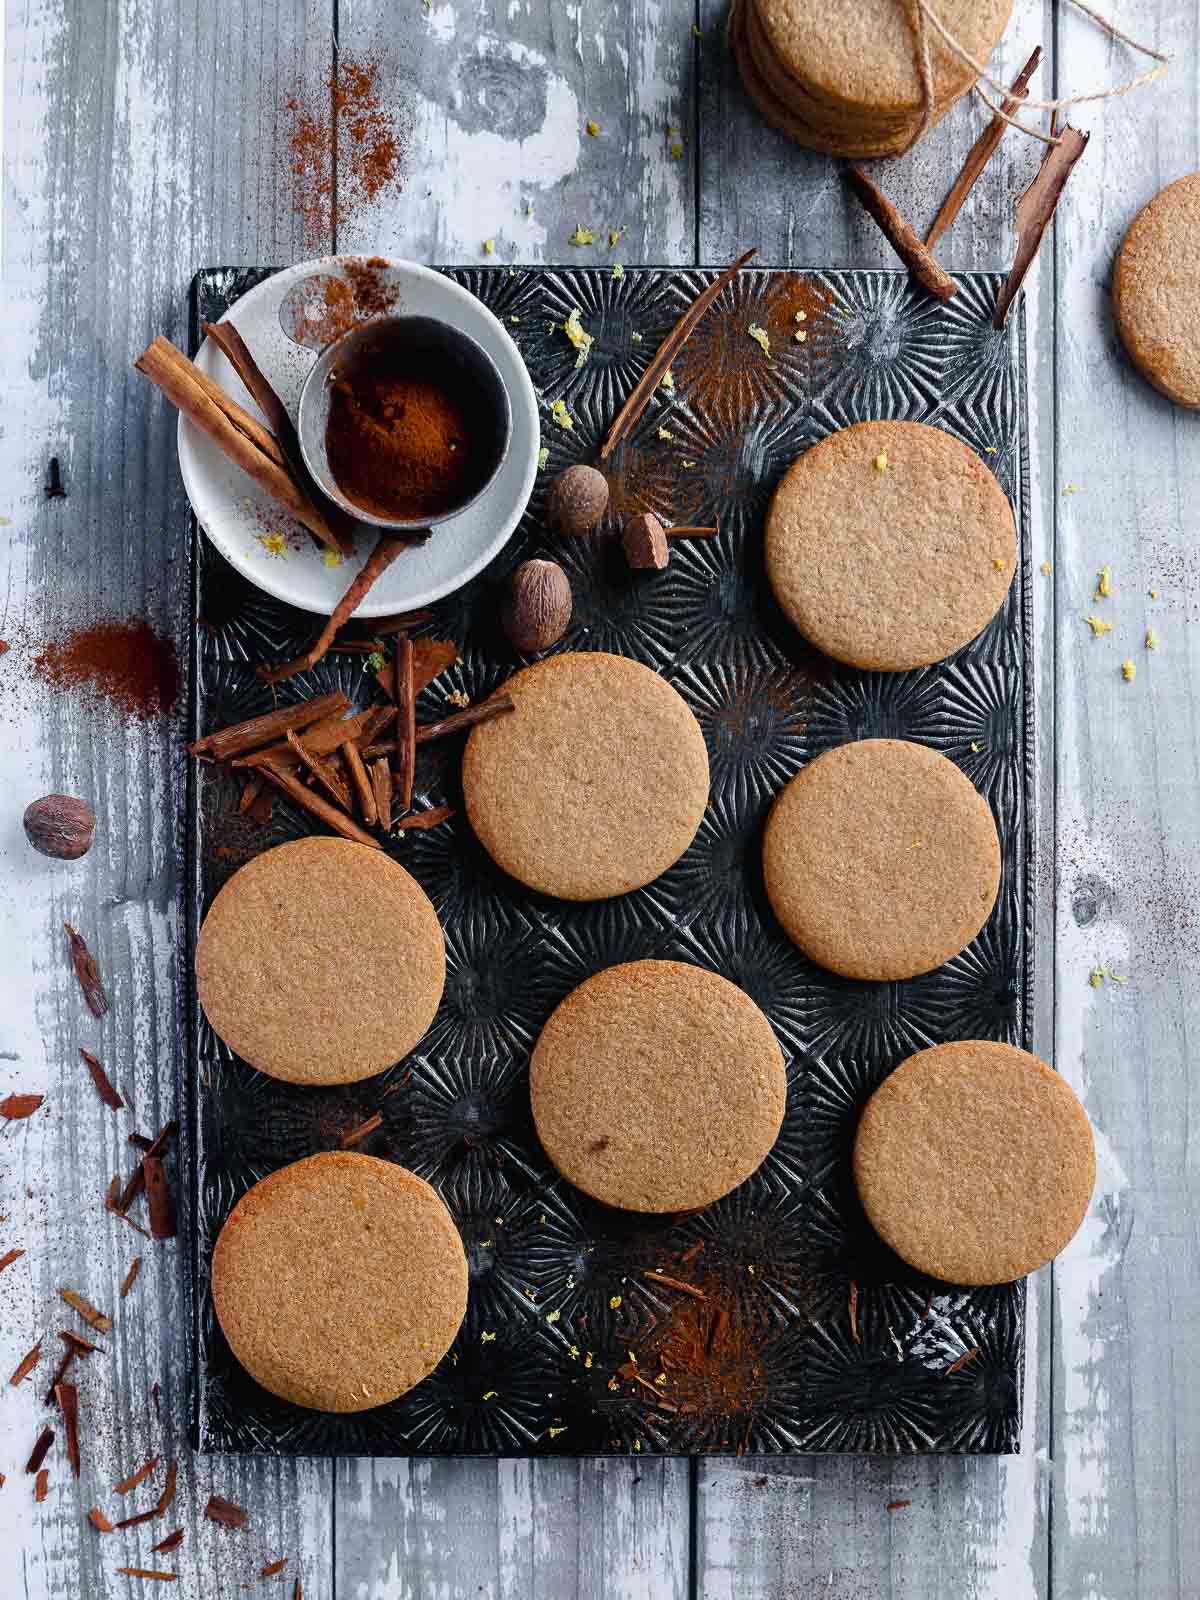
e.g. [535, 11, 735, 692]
[1053, 0, 1200, 1600]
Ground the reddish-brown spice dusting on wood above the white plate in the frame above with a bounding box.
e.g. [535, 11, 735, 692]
[285, 56, 408, 246]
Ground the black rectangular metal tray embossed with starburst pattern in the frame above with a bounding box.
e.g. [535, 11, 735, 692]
[184, 267, 1032, 1456]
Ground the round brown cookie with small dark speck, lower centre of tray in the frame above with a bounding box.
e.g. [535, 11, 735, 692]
[530, 962, 787, 1211]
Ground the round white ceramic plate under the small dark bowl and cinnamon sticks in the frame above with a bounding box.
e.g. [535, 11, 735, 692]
[179, 256, 541, 618]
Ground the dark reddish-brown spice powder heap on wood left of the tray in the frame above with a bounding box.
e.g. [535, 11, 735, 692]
[32, 618, 179, 722]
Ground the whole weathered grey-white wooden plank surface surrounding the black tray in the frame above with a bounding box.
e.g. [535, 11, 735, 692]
[0, 0, 1200, 1600]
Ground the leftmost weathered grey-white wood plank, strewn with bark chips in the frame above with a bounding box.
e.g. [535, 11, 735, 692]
[0, 0, 333, 1600]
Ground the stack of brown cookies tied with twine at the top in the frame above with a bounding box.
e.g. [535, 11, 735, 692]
[728, 0, 1013, 158]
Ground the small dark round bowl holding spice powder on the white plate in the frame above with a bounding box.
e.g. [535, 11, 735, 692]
[298, 317, 512, 533]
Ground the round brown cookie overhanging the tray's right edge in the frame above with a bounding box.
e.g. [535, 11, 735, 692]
[854, 1038, 1096, 1283]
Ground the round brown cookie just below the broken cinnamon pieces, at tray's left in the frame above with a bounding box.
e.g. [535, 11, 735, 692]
[195, 838, 446, 1083]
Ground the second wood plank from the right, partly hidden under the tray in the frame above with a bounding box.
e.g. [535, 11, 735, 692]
[696, 0, 1054, 1600]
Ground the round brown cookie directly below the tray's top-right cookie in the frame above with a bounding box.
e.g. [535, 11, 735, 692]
[763, 739, 1000, 979]
